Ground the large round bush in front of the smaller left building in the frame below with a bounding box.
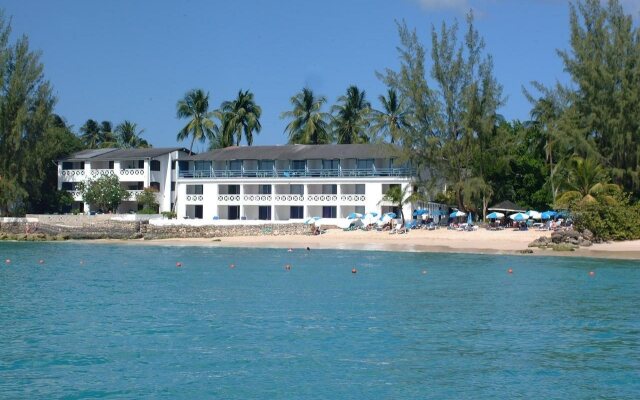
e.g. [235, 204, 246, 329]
[78, 175, 129, 212]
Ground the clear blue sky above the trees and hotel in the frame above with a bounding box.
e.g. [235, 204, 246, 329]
[0, 0, 640, 151]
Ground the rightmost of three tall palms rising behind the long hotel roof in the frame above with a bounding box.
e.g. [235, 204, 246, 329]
[371, 89, 411, 143]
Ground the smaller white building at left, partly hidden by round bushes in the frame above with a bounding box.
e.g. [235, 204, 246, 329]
[58, 147, 189, 213]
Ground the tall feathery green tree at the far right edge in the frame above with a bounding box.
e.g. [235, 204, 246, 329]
[558, 0, 640, 196]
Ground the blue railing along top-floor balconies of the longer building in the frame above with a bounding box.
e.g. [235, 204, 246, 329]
[179, 167, 416, 179]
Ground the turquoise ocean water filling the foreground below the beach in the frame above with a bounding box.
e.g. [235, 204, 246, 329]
[0, 242, 640, 399]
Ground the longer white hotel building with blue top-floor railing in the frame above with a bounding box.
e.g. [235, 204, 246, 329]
[175, 144, 415, 221]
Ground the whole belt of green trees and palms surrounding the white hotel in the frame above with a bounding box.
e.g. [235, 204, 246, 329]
[0, 0, 640, 239]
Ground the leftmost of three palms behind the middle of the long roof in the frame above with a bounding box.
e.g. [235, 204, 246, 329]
[280, 88, 331, 144]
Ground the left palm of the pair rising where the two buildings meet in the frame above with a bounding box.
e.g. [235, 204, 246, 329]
[177, 89, 218, 152]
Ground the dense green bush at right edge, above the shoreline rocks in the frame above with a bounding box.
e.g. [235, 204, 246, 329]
[571, 194, 640, 240]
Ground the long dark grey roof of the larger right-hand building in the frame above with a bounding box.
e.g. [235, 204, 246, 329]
[184, 144, 400, 161]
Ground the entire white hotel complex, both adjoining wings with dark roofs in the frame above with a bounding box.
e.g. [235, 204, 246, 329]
[58, 144, 437, 222]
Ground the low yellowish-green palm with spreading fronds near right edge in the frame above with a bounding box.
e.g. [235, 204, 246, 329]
[556, 157, 620, 208]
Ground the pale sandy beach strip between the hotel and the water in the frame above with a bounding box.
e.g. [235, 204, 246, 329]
[94, 229, 640, 260]
